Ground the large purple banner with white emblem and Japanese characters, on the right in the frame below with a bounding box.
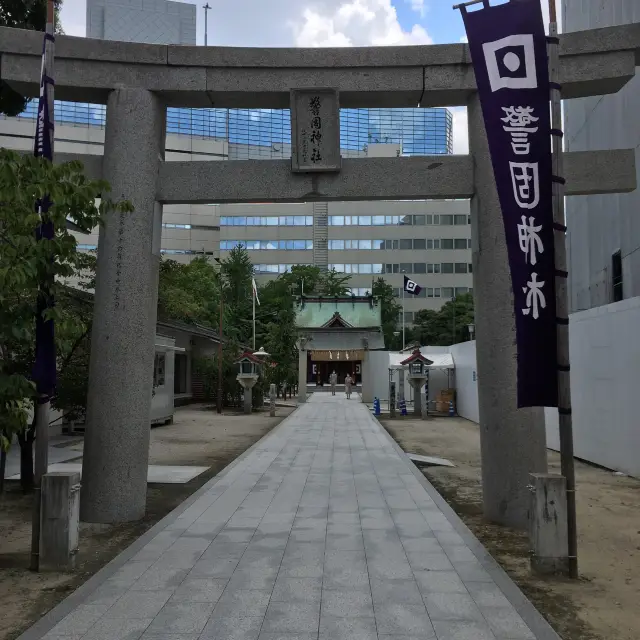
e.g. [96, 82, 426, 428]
[461, 0, 558, 407]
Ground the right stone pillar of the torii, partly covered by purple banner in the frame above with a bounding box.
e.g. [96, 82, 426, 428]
[468, 94, 547, 529]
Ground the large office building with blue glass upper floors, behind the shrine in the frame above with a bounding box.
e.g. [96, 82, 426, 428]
[0, 0, 472, 322]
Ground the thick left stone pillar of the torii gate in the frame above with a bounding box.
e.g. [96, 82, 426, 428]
[80, 88, 166, 523]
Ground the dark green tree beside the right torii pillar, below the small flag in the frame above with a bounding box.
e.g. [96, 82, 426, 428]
[411, 293, 474, 346]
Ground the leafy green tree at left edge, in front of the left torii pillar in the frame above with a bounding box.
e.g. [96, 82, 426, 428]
[0, 149, 130, 489]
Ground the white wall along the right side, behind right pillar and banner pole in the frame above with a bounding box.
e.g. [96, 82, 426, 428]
[451, 297, 640, 477]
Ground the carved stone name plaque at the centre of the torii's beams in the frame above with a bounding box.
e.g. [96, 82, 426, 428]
[291, 89, 340, 173]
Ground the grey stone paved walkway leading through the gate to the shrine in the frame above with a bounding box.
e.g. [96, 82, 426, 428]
[23, 394, 557, 640]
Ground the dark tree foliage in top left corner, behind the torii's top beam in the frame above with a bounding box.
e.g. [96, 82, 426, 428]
[0, 0, 64, 116]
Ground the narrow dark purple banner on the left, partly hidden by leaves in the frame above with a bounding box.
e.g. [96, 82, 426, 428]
[32, 33, 56, 401]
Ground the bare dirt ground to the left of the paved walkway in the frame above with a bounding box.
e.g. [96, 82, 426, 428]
[0, 407, 293, 640]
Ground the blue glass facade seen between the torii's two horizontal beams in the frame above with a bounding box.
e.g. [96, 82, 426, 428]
[8, 100, 453, 159]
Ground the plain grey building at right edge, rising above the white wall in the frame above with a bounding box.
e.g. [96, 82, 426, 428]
[562, 0, 640, 312]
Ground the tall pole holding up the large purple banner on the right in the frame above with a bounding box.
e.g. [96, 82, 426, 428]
[548, 0, 578, 578]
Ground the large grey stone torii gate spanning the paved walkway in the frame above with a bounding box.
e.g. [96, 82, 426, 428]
[0, 24, 640, 526]
